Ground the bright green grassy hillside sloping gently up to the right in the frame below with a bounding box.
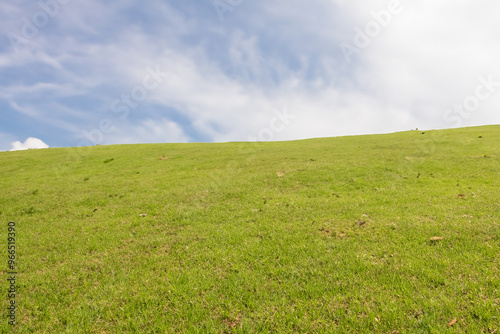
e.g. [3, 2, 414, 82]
[0, 126, 500, 333]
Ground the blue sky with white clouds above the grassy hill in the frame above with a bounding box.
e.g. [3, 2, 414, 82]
[0, 0, 500, 151]
